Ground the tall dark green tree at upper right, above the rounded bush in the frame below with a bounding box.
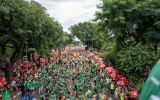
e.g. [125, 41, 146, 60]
[96, 0, 160, 52]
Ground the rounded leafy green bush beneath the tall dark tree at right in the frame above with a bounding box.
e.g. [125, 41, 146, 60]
[118, 45, 158, 83]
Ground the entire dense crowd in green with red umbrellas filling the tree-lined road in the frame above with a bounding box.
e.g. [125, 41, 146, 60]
[2, 48, 138, 100]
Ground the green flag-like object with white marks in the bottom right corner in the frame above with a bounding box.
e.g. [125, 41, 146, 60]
[139, 60, 160, 100]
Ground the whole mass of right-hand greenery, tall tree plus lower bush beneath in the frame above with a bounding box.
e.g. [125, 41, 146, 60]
[95, 0, 160, 89]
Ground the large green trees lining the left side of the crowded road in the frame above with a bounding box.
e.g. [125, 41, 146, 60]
[0, 0, 65, 82]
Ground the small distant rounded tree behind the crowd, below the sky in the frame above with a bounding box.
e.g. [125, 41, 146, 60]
[70, 22, 101, 49]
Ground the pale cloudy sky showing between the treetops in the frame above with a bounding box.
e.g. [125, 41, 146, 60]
[36, 0, 100, 32]
